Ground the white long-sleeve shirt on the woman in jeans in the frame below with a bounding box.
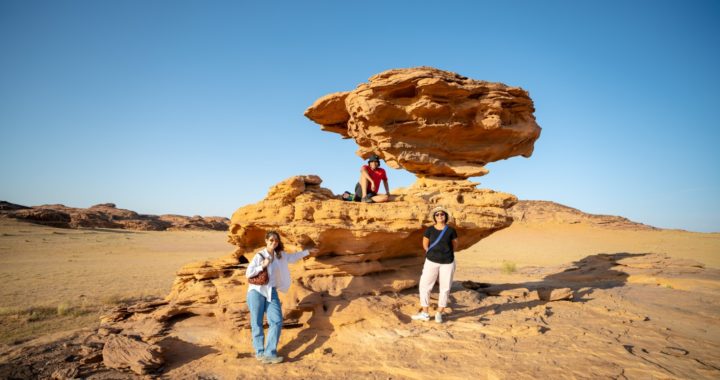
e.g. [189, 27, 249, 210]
[245, 248, 310, 302]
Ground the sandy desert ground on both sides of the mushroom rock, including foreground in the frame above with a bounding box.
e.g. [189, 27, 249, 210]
[0, 218, 720, 379]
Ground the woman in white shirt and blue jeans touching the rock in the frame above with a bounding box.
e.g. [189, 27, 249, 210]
[245, 231, 318, 364]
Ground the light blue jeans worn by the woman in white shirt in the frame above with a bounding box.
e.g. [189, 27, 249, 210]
[247, 288, 282, 357]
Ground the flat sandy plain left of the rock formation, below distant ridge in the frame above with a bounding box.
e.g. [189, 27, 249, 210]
[0, 218, 228, 344]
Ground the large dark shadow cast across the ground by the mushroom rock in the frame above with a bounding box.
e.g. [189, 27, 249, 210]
[447, 252, 648, 320]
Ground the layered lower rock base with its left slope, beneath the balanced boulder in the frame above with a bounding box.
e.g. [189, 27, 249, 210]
[98, 175, 517, 337]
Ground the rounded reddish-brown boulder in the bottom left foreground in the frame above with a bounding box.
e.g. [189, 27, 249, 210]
[103, 335, 164, 375]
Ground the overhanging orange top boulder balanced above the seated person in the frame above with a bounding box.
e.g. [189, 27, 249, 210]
[305, 67, 540, 179]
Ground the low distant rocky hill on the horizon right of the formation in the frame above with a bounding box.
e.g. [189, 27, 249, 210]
[508, 201, 657, 230]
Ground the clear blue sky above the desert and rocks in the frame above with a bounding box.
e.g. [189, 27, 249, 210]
[0, 0, 720, 231]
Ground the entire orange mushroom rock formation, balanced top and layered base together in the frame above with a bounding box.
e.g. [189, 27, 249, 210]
[101, 68, 540, 374]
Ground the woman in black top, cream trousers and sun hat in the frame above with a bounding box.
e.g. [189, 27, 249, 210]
[412, 207, 457, 323]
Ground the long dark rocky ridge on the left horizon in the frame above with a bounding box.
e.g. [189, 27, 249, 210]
[0, 201, 230, 231]
